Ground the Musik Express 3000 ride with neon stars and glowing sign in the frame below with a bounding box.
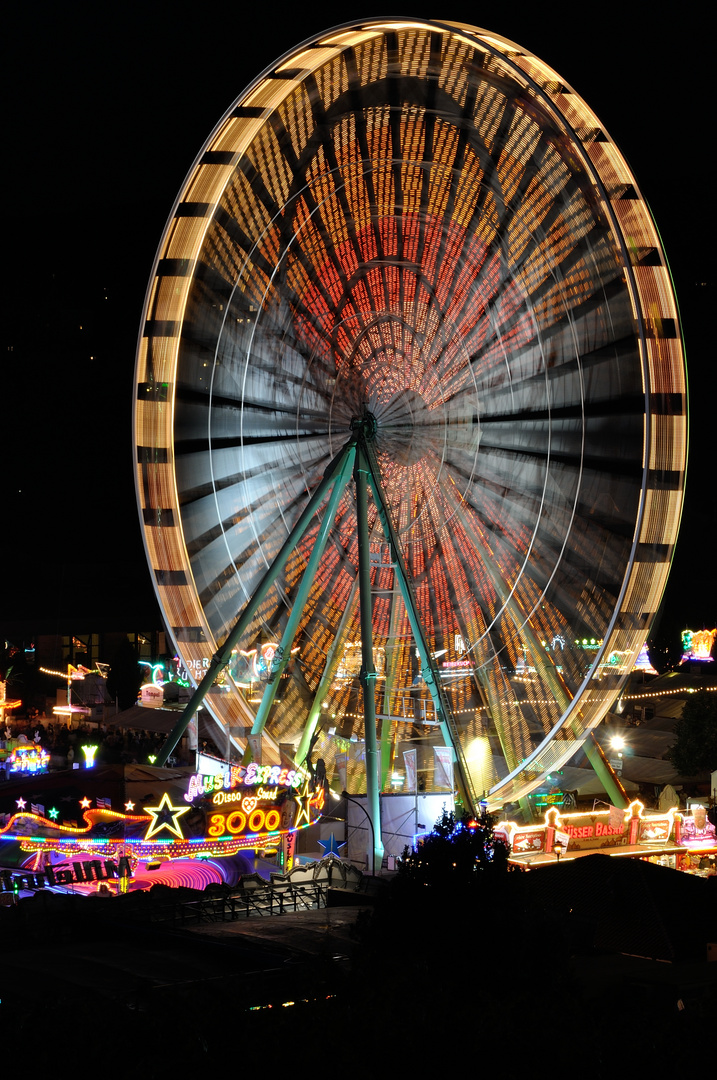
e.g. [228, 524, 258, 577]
[0, 755, 325, 892]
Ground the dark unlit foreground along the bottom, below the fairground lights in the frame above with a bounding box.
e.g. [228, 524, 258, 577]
[0, 856, 717, 1080]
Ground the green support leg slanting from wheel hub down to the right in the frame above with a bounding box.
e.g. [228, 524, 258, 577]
[357, 450, 477, 813]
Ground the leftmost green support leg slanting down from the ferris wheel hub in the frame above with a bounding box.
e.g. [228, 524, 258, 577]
[157, 440, 354, 766]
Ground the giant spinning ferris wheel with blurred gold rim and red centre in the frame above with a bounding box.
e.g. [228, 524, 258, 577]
[135, 19, 687, 805]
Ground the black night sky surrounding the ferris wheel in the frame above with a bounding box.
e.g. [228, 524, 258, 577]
[0, 0, 717, 646]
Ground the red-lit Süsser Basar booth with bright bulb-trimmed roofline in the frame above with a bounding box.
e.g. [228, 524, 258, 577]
[496, 800, 717, 876]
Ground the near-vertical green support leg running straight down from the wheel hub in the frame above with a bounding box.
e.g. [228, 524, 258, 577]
[353, 443, 383, 874]
